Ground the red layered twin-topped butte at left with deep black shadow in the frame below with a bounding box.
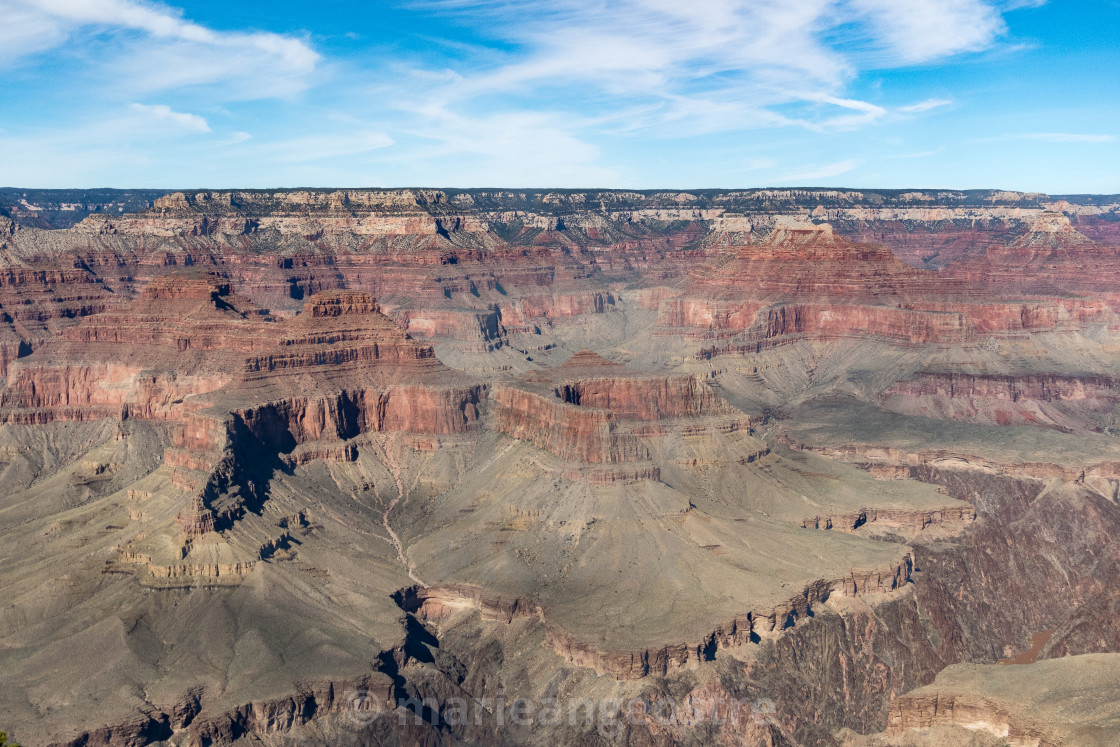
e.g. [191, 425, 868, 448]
[0, 277, 484, 539]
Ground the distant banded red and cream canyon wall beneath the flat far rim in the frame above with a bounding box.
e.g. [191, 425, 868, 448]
[0, 185, 1117, 365]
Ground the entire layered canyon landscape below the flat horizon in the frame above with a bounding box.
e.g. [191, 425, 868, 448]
[0, 189, 1120, 747]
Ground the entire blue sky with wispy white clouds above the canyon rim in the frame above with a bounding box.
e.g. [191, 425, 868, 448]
[0, 0, 1120, 194]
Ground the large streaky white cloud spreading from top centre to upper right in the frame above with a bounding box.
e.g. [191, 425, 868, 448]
[405, 0, 1005, 143]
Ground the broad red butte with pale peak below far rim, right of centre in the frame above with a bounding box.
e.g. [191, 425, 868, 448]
[656, 226, 1109, 356]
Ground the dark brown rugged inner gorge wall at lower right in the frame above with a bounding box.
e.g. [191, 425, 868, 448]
[750, 469, 1120, 747]
